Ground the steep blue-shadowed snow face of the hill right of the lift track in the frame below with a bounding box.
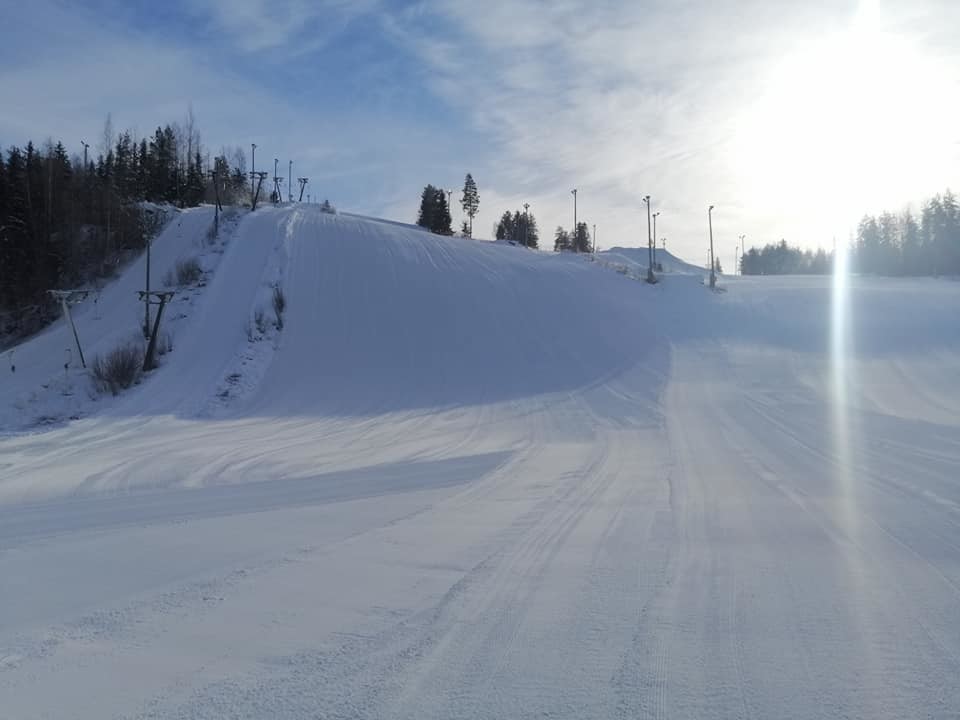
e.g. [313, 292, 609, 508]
[239, 208, 651, 416]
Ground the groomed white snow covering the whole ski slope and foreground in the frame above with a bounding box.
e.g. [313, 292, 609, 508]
[0, 206, 960, 720]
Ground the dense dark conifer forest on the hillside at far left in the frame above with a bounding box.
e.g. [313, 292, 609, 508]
[0, 114, 249, 336]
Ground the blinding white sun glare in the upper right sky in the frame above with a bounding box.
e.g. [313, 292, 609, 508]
[732, 0, 960, 236]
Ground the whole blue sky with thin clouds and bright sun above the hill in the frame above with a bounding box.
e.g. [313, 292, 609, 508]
[0, 0, 960, 265]
